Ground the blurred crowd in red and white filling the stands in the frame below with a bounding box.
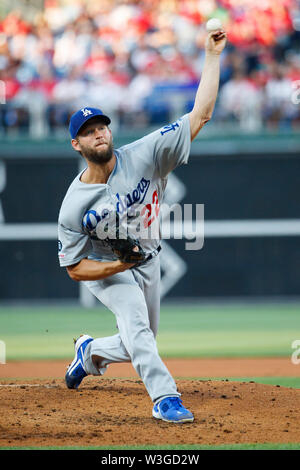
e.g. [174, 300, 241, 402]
[0, 0, 300, 137]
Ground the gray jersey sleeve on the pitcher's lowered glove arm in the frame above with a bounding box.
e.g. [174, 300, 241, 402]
[58, 223, 92, 266]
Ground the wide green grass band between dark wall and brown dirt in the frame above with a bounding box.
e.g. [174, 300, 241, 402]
[0, 304, 300, 361]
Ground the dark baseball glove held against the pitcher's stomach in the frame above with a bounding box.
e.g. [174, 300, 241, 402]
[104, 215, 147, 264]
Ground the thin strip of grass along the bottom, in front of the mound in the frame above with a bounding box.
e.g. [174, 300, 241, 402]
[0, 443, 300, 450]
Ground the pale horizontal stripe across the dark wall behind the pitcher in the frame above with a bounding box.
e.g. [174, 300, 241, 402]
[0, 219, 300, 241]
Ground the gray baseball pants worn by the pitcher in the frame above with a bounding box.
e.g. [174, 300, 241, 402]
[84, 256, 180, 403]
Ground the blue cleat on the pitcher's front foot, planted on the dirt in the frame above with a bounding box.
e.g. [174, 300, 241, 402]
[152, 397, 194, 423]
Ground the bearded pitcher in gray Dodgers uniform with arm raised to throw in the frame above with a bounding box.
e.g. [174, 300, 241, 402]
[58, 29, 226, 423]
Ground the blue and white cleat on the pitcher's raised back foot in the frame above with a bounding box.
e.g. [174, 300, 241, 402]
[65, 335, 94, 388]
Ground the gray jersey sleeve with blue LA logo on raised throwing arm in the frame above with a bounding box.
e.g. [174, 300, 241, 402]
[153, 114, 191, 178]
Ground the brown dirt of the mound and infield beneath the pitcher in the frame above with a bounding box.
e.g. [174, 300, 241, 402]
[0, 358, 300, 447]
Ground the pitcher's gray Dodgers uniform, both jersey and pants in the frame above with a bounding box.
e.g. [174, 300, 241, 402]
[58, 114, 191, 402]
